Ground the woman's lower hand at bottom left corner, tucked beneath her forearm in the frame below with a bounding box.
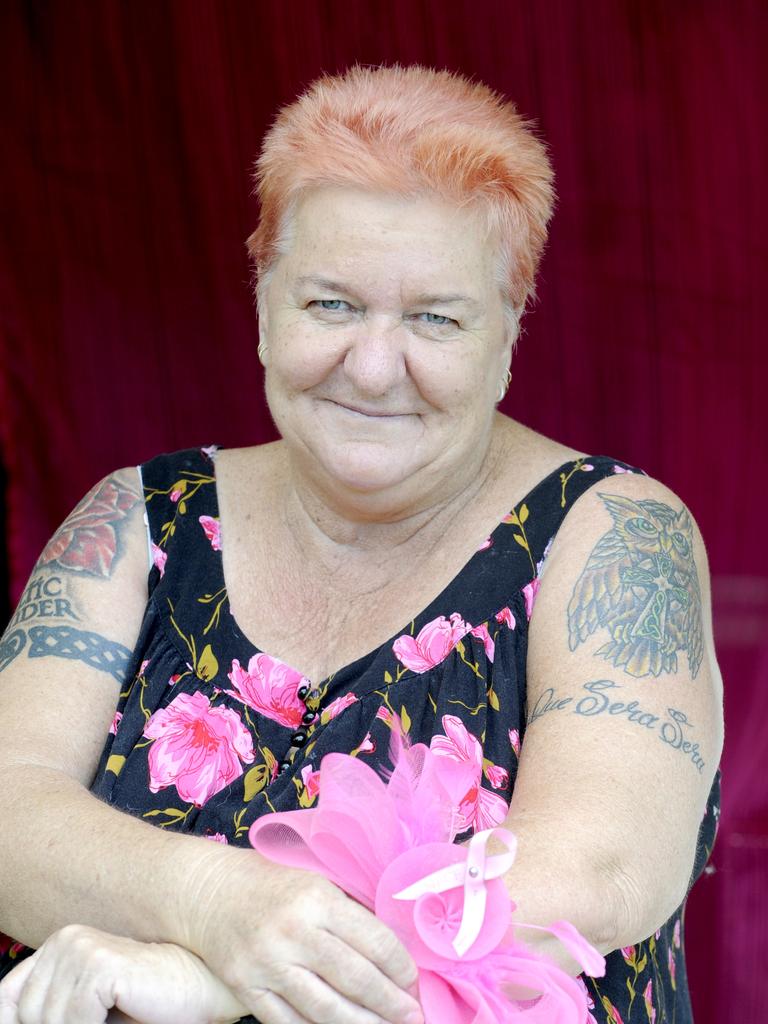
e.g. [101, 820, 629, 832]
[0, 925, 247, 1024]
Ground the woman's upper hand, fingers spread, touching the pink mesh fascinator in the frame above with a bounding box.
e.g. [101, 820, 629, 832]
[185, 849, 423, 1024]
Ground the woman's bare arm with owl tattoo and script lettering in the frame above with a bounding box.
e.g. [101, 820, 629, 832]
[495, 473, 723, 975]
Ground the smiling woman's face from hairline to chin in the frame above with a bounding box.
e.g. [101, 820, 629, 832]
[259, 186, 514, 503]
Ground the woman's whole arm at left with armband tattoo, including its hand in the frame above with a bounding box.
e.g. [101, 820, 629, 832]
[0, 469, 418, 1024]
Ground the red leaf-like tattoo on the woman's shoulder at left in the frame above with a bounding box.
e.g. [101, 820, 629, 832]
[38, 477, 138, 578]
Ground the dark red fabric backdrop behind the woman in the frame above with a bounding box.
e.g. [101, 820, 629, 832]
[0, 0, 768, 1024]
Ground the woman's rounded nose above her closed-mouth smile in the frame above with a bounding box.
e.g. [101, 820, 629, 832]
[344, 315, 408, 397]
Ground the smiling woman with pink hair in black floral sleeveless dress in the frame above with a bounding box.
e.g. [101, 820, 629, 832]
[0, 67, 722, 1024]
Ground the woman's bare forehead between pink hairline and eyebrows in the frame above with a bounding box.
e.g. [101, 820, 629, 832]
[285, 186, 498, 297]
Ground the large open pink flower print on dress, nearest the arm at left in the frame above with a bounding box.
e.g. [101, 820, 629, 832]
[144, 690, 260, 807]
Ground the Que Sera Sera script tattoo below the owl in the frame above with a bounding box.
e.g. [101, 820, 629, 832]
[527, 679, 705, 774]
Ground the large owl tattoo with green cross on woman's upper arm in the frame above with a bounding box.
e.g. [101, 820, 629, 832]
[568, 494, 703, 678]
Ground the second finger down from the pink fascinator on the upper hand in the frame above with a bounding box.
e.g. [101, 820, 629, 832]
[307, 932, 420, 1024]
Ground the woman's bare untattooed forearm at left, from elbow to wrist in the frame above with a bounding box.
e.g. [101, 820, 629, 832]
[0, 767, 239, 947]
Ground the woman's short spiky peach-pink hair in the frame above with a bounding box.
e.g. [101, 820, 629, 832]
[247, 65, 555, 311]
